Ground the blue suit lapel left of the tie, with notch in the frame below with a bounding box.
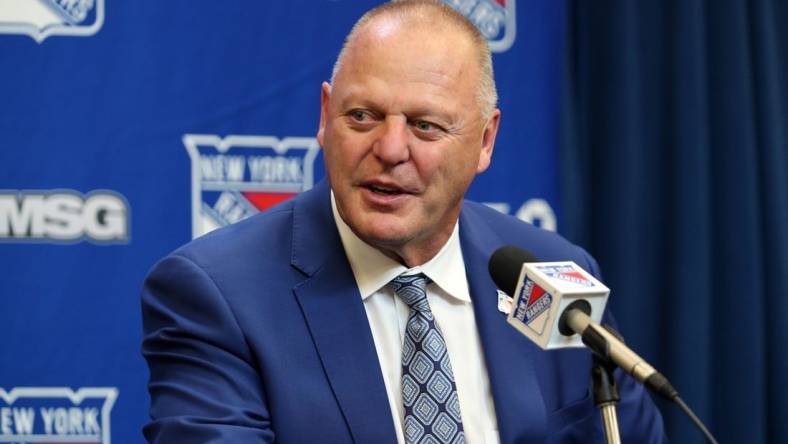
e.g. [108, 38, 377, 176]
[292, 182, 396, 443]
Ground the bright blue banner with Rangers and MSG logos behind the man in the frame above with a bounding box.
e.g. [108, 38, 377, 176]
[0, 0, 564, 444]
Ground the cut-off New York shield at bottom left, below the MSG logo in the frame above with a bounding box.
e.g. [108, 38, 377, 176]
[0, 387, 118, 444]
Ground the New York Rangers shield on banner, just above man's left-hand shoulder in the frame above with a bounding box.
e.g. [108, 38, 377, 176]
[183, 134, 320, 237]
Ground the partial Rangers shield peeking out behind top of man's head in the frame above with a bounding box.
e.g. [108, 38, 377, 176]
[444, 0, 517, 52]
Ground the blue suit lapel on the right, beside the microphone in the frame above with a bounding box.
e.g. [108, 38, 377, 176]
[460, 206, 547, 443]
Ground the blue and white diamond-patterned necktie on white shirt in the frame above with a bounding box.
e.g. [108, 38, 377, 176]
[391, 274, 465, 444]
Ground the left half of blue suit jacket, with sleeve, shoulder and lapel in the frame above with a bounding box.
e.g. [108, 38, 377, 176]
[142, 183, 396, 443]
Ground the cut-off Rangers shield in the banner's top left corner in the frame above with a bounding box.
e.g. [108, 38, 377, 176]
[0, 0, 104, 43]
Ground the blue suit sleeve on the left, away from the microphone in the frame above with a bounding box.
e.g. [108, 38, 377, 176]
[142, 251, 274, 444]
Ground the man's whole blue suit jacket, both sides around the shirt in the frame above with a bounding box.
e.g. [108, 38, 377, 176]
[142, 182, 664, 444]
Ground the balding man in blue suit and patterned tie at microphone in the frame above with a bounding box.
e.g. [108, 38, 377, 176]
[143, 0, 663, 443]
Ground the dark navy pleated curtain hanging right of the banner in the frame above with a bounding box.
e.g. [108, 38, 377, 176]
[559, 0, 788, 443]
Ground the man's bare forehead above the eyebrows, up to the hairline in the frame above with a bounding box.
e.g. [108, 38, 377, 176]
[334, 18, 479, 109]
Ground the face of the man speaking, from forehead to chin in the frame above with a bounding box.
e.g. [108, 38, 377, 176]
[317, 19, 499, 266]
